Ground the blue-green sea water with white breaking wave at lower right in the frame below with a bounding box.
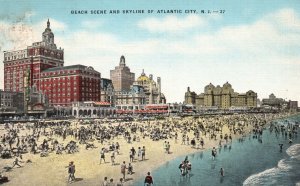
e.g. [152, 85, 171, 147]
[134, 115, 300, 186]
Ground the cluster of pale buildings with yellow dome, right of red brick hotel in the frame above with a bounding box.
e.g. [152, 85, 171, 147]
[109, 56, 166, 110]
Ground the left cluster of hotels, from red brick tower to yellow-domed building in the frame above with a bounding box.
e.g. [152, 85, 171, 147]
[3, 19, 166, 110]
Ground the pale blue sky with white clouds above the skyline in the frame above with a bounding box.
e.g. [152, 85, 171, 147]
[0, 0, 300, 102]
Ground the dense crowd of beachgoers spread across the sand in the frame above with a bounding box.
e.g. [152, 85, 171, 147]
[0, 114, 294, 185]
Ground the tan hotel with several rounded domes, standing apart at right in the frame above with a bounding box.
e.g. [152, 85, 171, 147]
[184, 82, 257, 110]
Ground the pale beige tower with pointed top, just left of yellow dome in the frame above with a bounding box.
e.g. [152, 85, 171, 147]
[110, 56, 135, 91]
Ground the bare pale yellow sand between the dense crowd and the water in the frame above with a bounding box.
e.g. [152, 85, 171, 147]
[0, 113, 290, 186]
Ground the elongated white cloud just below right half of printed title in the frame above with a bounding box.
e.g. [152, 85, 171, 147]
[138, 15, 206, 33]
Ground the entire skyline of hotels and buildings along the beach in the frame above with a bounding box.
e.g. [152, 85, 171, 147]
[1, 19, 297, 117]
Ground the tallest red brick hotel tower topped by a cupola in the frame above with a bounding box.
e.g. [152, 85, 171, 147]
[4, 20, 64, 92]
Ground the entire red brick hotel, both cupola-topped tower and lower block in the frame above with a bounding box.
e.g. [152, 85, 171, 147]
[4, 20, 101, 106]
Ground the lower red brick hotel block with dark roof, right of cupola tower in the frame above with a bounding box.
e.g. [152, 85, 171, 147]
[40, 65, 101, 108]
